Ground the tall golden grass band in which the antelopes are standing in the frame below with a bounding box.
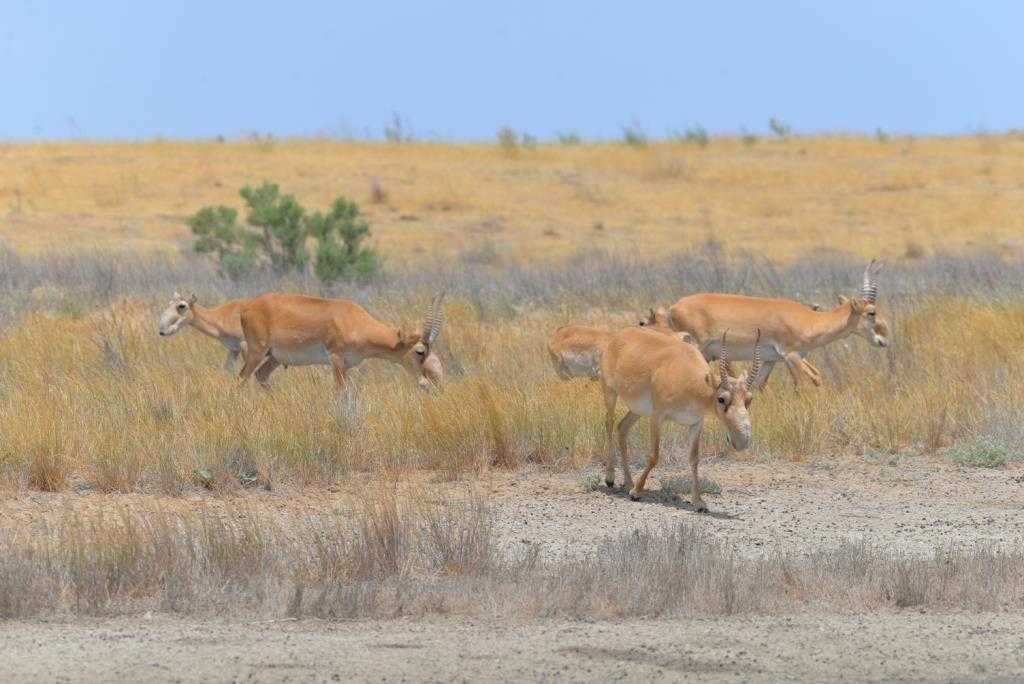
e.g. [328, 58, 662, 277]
[0, 288, 1024, 494]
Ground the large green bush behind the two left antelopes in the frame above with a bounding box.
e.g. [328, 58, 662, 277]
[185, 183, 380, 283]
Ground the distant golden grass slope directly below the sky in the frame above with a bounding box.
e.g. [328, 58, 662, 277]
[0, 135, 1024, 264]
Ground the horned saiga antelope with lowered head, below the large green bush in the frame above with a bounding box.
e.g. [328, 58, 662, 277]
[240, 293, 444, 392]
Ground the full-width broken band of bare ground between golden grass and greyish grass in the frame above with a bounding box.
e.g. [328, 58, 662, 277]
[6, 450, 1024, 559]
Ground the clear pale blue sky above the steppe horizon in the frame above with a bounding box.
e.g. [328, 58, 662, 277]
[0, 0, 1024, 139]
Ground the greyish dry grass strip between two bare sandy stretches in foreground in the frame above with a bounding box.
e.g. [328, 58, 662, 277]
[0, 491, 1024, 621]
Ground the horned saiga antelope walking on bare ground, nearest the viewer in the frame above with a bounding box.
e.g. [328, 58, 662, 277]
[600, 328, 761, 512]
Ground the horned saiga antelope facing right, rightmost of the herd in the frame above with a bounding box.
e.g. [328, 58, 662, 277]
[669, 259, 890, 387]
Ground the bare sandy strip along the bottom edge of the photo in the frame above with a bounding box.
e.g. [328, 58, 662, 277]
[0, 612, 1024, 682]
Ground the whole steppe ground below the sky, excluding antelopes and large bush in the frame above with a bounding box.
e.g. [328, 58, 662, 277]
[0, 135, 1024, 681]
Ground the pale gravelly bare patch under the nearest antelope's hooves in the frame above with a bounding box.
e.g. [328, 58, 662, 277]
[479, 458, 1024, 556]
